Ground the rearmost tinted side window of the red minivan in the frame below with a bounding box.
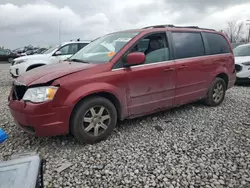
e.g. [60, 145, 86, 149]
[204, 33, 230, 55]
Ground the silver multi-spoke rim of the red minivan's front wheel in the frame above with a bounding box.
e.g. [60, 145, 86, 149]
[83, 106, 111, 136]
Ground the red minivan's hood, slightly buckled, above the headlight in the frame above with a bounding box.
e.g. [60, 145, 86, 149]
[17, 61, 97, 86]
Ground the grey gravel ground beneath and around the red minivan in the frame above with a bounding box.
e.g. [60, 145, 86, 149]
[0, 71, 250, 188]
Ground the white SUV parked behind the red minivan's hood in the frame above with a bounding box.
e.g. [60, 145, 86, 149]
[10, 41, 91, 78]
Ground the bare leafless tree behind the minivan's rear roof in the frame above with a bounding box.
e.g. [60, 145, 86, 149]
[223, 21, 243, 43]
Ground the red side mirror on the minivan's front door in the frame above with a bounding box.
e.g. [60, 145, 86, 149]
[124, 52, 146, 67]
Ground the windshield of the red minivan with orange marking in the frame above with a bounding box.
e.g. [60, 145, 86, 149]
[70, 32, 138, 63]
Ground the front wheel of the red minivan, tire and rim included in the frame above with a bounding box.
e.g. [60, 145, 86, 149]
[70, 97, 117, 144]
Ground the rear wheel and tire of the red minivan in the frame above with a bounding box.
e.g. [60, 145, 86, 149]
[205, 77, 227, 107]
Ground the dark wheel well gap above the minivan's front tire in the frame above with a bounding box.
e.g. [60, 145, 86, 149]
[71, 92, 121, 119]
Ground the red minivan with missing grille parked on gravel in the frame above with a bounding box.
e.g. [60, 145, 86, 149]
[9, 25, 236, 143]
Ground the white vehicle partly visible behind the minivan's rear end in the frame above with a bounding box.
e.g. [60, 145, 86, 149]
[234, 43, 250, 83]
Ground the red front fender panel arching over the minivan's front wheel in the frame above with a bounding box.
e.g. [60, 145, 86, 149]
[64, 83, 127, 115]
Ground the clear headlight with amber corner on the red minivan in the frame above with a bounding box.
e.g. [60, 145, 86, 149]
[23, 86, 58, 102]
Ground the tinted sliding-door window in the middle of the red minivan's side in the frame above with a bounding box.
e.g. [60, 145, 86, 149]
[172, 32, 205, 59]
